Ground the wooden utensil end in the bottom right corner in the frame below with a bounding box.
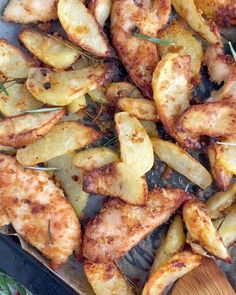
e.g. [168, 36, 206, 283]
[171, 258, 236, 295]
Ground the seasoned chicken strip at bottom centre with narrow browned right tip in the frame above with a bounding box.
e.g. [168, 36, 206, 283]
[83, 189, 189, 262]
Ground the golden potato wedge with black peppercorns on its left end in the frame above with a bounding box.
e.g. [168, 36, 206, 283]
[26, 64, 112, 105]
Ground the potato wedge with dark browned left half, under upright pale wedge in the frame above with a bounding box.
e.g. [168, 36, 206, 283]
[83, 162, 148, 205]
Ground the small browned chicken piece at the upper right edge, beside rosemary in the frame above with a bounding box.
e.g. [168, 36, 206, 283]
[204, 43, 236, 84]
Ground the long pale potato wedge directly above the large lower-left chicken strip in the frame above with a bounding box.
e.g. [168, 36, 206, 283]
[16, 121, 100, 165]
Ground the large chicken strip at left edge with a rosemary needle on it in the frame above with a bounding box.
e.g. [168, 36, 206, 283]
[0, 154, 81, 269]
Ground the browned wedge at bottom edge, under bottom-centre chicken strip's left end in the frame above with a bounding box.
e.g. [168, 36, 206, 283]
[84, 260, 134, 295]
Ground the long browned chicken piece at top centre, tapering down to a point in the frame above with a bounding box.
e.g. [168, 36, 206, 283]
[111, 0, 171, 97]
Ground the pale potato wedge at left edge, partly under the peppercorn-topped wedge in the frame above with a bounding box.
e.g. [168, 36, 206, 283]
[0, 82, 43, 117]
